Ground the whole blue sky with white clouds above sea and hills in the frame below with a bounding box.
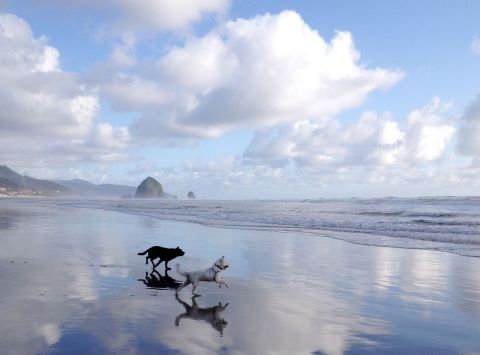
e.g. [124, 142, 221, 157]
[0, 0, 480, 199]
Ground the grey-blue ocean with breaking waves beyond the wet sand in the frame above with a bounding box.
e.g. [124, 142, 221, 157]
[46, 197, 480, 257]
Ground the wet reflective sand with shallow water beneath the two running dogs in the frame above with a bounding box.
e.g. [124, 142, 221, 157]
[0, 200, 480, 354]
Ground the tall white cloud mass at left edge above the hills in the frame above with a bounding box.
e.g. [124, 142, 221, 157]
[0, 14, 130, 167]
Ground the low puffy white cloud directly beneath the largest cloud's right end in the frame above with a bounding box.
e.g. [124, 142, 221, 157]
[244, 112, 405, 167]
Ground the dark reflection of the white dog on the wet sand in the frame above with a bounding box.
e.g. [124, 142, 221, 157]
[175, 296, 228, 336]
